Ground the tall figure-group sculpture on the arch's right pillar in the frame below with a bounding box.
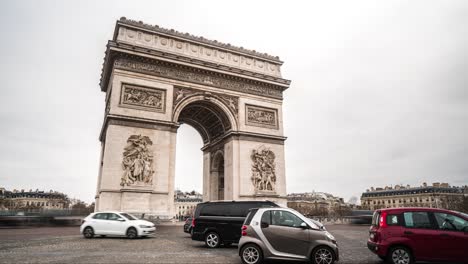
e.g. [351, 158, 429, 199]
[250, 146, 276, 191]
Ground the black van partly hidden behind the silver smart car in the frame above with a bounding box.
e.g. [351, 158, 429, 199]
[192, 201, 279, 248]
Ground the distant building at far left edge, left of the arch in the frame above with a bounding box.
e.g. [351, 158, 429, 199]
[0, 188, 70, 210]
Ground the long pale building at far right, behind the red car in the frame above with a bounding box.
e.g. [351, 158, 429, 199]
[361, 182, 468, 211]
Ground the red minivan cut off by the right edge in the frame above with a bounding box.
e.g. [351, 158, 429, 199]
[367, 208, 468, 264]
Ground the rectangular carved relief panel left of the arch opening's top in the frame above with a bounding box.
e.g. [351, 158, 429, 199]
[120, 83, 166, 112]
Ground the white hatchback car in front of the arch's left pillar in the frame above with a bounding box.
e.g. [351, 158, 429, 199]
[80, 211, 156, 238]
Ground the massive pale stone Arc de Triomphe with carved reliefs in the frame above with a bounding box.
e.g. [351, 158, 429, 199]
[96, 18, 290, 217]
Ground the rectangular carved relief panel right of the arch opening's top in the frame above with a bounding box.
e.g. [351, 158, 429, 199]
[245, 105, 278, 129]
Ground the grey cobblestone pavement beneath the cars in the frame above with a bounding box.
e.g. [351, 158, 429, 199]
[0, 225, 383, 264]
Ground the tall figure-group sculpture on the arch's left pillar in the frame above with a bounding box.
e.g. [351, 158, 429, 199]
[120, 135, 154, 187]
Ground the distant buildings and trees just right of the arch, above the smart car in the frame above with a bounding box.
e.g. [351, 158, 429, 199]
[287, 192, 352, 217]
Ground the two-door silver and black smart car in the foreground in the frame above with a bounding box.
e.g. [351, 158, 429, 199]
[239, 208, 338, 264]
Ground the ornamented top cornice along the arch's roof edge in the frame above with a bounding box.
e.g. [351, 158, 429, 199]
[114, 17, 283, 64]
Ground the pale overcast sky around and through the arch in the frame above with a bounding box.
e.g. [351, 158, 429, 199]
[0, 0, 468, 202]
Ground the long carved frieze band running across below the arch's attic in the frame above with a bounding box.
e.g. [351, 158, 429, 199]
[114, 58, 283, 99]
